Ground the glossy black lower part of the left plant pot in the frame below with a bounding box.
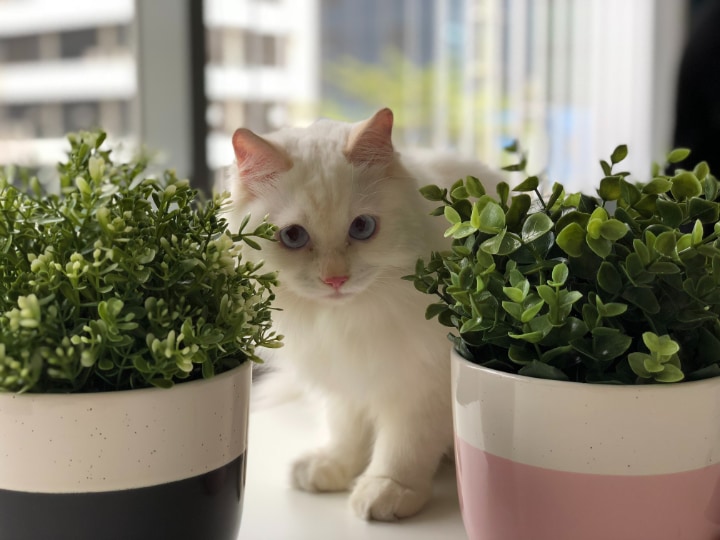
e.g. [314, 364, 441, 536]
[0, 455, 245, 540]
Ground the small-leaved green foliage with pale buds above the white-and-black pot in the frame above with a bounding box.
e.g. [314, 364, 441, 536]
[0, 133, 280, 392]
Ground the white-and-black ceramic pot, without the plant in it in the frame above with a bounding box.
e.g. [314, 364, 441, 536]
[0, 362, 252, 540]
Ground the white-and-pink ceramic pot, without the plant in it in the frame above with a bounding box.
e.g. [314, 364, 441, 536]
[452, 351, 720, 540]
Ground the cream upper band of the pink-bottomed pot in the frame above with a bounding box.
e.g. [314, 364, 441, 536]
[452, 351, 720, 475]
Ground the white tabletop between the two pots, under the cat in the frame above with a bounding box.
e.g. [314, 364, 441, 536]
[238, 401, 467, 540]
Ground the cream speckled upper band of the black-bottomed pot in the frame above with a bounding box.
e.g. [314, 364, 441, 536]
[0, 362, 252, 493]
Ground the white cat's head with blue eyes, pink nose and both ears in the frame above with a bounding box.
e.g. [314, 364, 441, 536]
[228, 109, 419, 303]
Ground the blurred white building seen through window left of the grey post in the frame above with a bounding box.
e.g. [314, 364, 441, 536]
[0, 0, 136, 165]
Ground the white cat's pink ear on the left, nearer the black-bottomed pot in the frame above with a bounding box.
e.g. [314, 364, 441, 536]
[232, 128, 292, 191]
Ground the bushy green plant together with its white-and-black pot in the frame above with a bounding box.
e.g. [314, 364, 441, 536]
[0, 133, 279, 540]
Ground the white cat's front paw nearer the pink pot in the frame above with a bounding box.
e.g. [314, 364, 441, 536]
[350, 476, 432, 521]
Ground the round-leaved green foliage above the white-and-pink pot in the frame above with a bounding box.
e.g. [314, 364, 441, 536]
[406, 146, 720, 384]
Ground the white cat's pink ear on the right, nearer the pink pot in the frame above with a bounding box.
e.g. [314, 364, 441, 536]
[345, 108, 395, 165]
